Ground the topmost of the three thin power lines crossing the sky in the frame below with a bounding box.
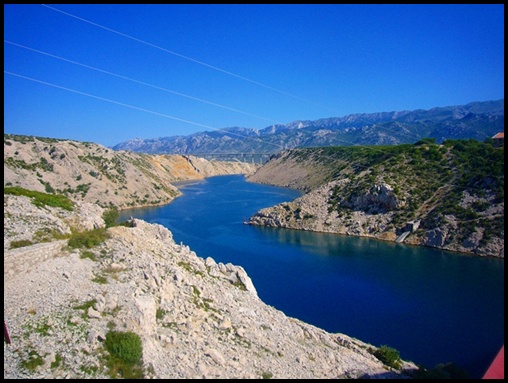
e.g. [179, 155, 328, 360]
[41, 4, 338, 110]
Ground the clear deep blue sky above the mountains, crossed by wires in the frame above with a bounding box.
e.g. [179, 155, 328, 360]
[4, 4, 504, 146]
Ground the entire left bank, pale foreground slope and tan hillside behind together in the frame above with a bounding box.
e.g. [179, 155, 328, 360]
[4, 136, 423, 379]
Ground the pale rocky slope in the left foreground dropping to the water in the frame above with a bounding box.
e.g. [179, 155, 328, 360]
[4, 196, 416, 379]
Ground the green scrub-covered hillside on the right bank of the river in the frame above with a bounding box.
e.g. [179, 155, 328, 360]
[248, 139, 504, 258]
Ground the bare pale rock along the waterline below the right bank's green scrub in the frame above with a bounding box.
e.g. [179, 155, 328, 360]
[248, 180, 504, 258]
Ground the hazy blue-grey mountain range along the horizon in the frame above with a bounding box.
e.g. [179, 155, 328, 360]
[113, 99, 504, 155]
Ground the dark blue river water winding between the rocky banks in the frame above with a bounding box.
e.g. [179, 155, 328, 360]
[120, 175, 504, 378]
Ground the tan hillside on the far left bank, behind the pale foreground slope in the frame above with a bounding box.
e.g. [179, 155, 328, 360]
[4, 134, 258, 209]
